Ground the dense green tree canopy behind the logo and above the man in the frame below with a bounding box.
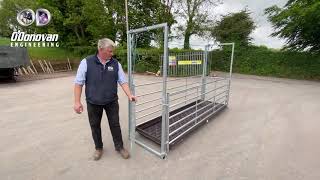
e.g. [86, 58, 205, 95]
[0, 0, 175, 47]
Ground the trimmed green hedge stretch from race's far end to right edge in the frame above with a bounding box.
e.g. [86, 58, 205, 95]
[212, 46, 320, 80]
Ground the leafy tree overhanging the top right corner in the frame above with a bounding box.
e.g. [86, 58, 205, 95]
[265, 0, 320, 52]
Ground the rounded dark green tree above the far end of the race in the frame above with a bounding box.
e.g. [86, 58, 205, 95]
[211, 10, 256, 45]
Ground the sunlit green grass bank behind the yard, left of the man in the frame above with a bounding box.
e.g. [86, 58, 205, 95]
[0, 37, 80, 61]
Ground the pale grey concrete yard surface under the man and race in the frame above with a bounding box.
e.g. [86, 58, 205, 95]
[0, 74, 320, 180]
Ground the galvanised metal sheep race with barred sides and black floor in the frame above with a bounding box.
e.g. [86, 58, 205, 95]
[128, 23, 234, 159]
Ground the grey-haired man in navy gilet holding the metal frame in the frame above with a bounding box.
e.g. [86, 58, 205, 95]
[74, 38, 136, 160]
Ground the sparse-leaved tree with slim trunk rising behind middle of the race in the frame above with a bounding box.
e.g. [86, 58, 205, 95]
[176, 0, 220, 49]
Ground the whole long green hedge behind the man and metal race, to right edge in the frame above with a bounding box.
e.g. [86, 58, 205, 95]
[72, 46, 320, 80]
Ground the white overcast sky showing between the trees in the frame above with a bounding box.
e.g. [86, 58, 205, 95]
[170, 0, 287, 49]
